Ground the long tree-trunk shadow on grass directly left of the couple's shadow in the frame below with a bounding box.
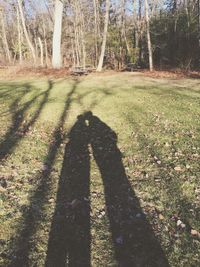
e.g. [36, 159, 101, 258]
[9, 81, 78, 267]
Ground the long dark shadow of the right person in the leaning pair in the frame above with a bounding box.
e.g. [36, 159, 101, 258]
[85, 112, 169, 267]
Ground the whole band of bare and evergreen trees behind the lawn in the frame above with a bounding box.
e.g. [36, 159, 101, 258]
[0, 0, 200, 71]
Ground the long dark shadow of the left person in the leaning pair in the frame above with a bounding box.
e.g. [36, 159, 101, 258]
[46, 116, 90, 267]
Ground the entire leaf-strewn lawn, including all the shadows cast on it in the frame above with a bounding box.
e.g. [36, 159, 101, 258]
[0, 73, 200, 267]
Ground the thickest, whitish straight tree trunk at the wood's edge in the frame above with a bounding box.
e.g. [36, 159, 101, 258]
[52, 0, 64, 69]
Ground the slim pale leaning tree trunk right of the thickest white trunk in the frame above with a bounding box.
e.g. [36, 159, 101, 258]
[97, 0, 110, 71]
